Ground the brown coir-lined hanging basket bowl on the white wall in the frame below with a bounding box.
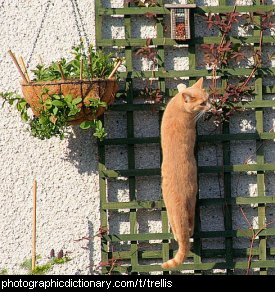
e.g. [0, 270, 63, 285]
[21, 78, 118, 124]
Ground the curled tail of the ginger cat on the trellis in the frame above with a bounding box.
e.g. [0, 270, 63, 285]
[161, 212, 190, 269]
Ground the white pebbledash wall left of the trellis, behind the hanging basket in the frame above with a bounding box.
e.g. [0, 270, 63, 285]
[0, 0, 100, 274]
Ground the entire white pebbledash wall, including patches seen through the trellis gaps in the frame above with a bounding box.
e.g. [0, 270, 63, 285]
[0, 0, 275, 274]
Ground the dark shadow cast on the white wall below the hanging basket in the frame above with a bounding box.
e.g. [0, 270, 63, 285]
[64, 126, 98, 175]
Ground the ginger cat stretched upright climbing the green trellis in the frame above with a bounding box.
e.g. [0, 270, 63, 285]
[161, 78, 210, 269]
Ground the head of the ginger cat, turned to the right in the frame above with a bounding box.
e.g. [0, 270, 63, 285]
[178, 77, 211, 113]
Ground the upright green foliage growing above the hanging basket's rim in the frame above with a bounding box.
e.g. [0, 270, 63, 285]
[32, 43, 114, 81]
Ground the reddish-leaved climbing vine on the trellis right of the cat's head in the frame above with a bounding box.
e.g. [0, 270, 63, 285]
[201, 6, 274, 126]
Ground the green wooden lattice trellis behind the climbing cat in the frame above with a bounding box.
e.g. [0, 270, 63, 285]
[95, 0, 275, 274]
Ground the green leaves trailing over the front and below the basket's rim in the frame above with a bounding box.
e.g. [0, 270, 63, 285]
[0, 88, 107, 140]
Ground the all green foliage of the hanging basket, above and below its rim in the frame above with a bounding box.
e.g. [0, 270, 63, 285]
[0, 42, 118, 140]
